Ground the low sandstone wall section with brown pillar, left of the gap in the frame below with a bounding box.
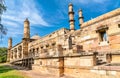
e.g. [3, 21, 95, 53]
[32, 54, 95, 76]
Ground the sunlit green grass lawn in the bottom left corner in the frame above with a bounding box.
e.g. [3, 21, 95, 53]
[0, 65, 30, 78]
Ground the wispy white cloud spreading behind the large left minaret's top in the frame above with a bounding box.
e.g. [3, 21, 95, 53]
[2, 0, 49, 37]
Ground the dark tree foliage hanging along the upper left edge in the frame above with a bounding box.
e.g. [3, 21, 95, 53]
[0, 0, 7, 38]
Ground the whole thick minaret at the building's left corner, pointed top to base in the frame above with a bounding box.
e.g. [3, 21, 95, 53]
[22, 18, 30, 58]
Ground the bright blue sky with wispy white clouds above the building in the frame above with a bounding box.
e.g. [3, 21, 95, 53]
[0, 0, 120, 47]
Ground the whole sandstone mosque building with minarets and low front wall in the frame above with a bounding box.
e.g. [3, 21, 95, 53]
[7, 4, 120, 78]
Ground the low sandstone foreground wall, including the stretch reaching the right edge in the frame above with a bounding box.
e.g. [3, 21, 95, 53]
[32, 53, 120, 78]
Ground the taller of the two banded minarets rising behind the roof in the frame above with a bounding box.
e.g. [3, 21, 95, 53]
[68, 3, 75, 31]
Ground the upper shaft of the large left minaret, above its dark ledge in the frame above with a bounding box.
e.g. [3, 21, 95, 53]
[24, 18, 30, 39]
